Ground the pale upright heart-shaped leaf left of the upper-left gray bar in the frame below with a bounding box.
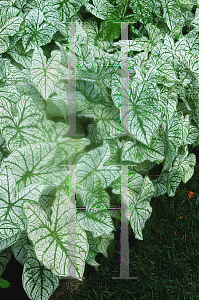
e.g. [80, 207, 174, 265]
[31, 48, 61, 100]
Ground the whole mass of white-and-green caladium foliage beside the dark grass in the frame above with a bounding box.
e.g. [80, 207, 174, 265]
[0, 0, 199, 300]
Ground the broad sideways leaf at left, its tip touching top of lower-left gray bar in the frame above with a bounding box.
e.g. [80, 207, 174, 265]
[2, 143, 68, 188]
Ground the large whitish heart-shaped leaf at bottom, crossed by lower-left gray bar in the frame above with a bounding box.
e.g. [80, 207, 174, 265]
[23, 190, 88, 280]
